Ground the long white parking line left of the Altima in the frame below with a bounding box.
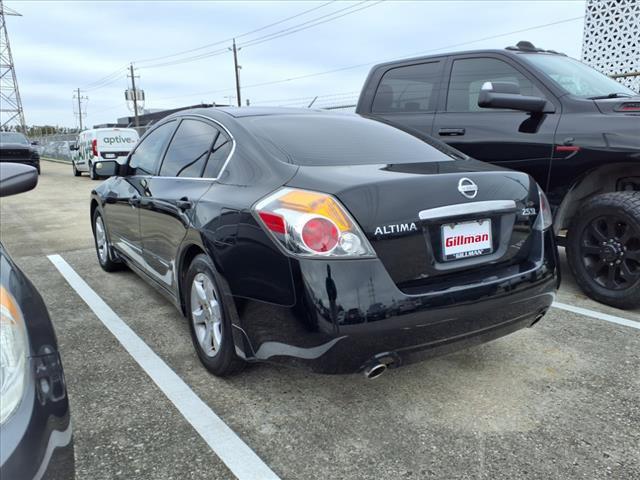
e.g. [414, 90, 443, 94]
[48, 255, 279, 480]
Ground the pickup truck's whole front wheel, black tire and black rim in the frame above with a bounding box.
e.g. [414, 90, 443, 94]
[567, 192, 640, 309]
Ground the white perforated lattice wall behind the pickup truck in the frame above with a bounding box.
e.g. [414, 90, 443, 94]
[582, 0, 640, 92]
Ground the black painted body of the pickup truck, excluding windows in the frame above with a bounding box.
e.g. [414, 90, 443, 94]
[356, 49, 640, 229]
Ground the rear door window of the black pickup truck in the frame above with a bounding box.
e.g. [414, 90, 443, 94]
[371, 62, 441, 113]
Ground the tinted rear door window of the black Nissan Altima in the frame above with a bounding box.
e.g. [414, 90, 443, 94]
[160, 118, 218, 177]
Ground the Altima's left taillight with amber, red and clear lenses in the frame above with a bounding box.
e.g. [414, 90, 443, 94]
[254, 188, 375, 258]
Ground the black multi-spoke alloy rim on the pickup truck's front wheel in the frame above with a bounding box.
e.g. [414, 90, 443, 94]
[580, 215, 640, 290]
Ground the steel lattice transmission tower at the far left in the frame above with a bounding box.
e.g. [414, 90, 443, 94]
[0, 0, 27, 132]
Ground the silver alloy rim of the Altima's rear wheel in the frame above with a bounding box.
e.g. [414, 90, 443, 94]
[191, 272, 222, 357]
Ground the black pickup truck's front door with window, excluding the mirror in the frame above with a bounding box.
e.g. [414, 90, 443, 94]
[433, 54, 560, 189]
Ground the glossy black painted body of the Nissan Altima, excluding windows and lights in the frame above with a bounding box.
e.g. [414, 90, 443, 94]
[91, 108, 559, 373]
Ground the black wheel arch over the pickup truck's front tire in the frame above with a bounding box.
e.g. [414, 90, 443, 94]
[554, 163, 640, 234]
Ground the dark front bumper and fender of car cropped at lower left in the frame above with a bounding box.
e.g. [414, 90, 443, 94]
[0, 244, 75, 480]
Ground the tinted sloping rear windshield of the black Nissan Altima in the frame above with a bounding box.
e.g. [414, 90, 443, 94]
[242, 114, 452, 166]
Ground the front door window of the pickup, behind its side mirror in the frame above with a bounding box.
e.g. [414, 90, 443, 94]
[447, 58, 544, 112]
